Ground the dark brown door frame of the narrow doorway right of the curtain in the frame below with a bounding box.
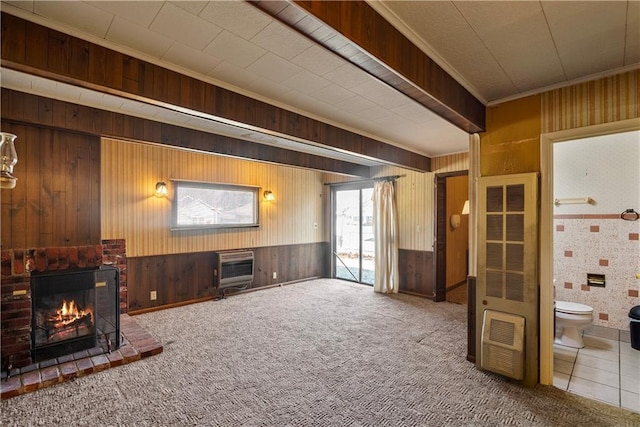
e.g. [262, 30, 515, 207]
[433, 170, 469, 302]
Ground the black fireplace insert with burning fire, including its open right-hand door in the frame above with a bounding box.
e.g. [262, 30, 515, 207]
[31, 266, 120, 362]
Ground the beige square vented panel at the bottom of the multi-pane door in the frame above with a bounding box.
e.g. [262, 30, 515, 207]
[481, 310, 525, 380]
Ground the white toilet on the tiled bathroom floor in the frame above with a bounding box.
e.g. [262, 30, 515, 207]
[555, 301, 593, 348]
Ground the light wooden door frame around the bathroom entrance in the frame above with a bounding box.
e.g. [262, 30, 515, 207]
[539, 118, 640, 385]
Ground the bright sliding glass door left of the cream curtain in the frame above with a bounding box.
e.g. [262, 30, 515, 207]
[332, 186, 375, 285]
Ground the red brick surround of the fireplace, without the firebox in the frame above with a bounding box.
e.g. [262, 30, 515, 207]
[0, 239, 127, 371]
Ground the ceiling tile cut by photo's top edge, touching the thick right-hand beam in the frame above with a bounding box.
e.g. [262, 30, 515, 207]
[198, 1, 271, 40]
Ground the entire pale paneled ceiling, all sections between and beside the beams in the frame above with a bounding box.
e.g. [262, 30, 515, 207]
[1, 1, 640, 165]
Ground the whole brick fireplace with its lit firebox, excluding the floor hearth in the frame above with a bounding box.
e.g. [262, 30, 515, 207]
[0, 244, 127, 375]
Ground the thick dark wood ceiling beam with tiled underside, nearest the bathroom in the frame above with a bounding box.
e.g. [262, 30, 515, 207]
[249, 0, 485, 133]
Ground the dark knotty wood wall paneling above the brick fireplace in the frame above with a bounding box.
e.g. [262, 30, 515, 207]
[1, 121, 101, 249]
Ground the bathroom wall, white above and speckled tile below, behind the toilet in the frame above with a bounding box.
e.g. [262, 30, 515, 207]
[553, 131, 640, 330]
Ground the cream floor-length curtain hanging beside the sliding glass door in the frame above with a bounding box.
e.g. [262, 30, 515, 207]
[373, 181, 399, 294]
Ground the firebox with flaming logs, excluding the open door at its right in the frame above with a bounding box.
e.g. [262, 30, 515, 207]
[31, 270, 97, 361]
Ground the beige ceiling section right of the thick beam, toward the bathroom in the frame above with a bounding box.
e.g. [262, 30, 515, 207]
[370, 0, 640, 104]
